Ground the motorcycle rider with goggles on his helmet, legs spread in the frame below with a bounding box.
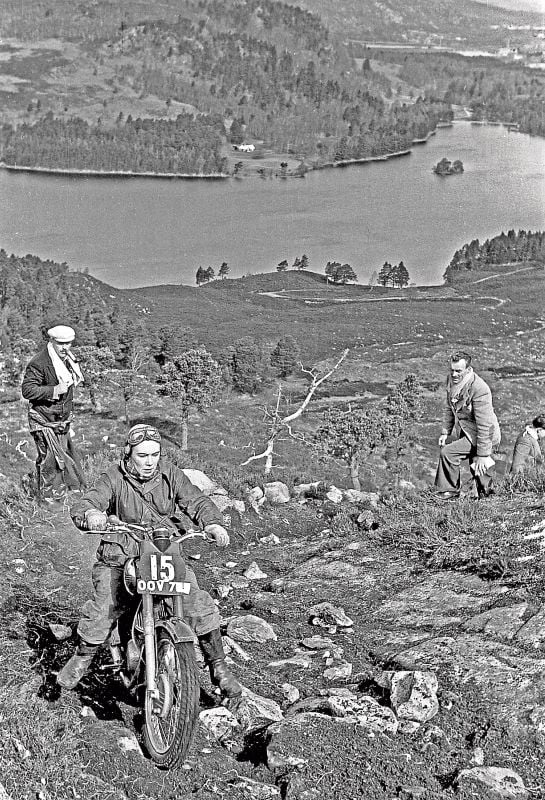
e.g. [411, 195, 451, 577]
[57, 424, 242, 697]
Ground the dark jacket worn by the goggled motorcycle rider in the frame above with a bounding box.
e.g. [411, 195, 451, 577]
[70, 459, 223, 566]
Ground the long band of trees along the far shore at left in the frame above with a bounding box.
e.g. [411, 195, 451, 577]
[0, 112, 226, 175]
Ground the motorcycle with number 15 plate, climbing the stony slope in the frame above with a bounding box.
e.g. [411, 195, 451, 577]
[108, 520, 207, 769]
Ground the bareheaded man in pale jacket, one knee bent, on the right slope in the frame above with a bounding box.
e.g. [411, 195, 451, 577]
[435, 352, 501, 500]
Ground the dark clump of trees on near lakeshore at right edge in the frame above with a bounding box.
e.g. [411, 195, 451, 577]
[443, 230, 545, 283]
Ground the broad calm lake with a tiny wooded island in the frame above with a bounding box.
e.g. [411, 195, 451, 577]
[0, 122, 545, 288]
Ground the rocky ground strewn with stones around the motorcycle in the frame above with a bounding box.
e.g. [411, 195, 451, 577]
[0, 472, 545, 800]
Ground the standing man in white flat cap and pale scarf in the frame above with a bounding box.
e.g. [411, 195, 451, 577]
[22, 325, 84, 503]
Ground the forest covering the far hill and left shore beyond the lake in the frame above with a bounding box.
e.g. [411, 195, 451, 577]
[0, 0, 452, 174]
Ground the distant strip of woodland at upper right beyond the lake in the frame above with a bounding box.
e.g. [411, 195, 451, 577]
[372, 50, 545, 136]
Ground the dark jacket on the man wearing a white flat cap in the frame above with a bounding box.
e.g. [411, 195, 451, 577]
[21, 347, 74, 422]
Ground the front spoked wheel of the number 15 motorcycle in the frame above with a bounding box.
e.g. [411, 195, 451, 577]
[144, 631, 199, 769]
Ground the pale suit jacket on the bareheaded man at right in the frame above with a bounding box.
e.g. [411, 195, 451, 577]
[443, 372, 501, 456]
